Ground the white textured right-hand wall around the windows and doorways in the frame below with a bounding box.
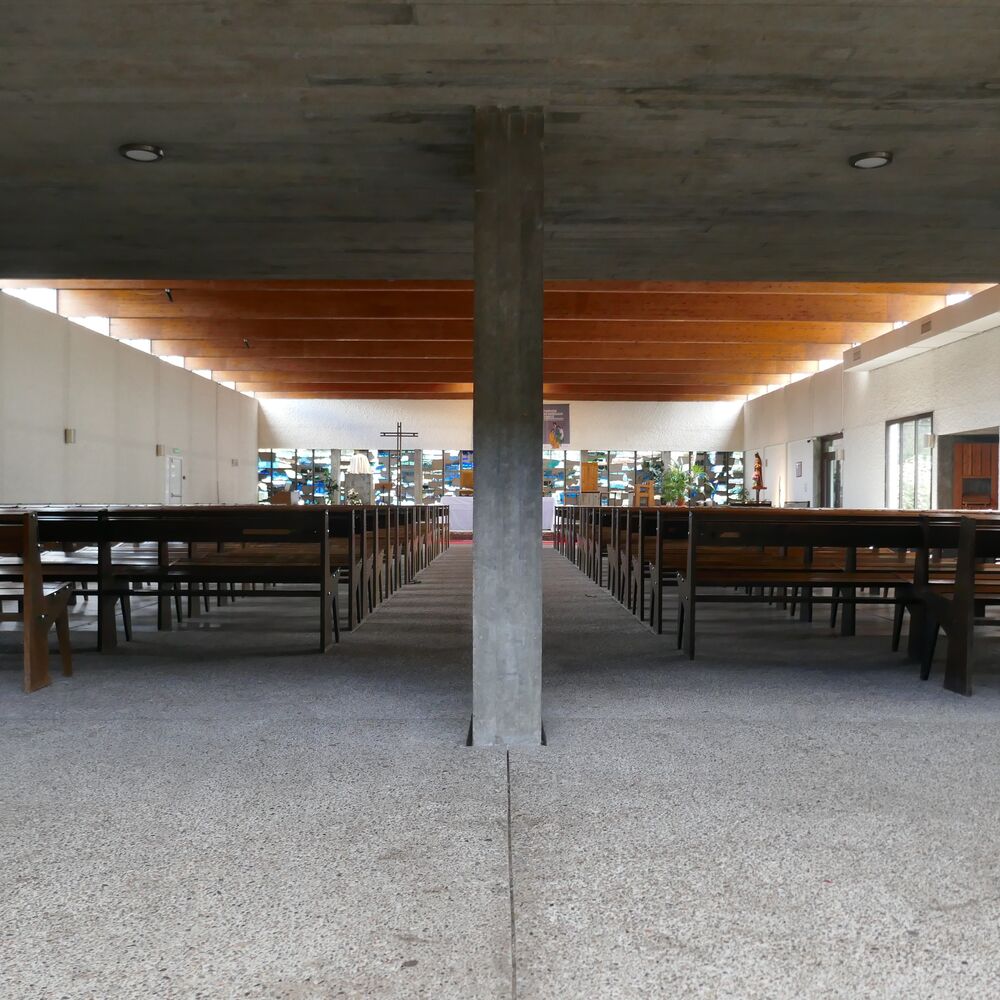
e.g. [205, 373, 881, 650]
[744, 329, 1000, 507]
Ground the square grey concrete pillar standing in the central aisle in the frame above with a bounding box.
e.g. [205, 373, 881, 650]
[472, 108, 543, 746]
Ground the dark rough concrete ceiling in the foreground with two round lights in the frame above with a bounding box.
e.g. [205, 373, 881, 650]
[0, 0, 1000, 281]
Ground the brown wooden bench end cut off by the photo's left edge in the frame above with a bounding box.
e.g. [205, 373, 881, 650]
[0, 514, 73, 694]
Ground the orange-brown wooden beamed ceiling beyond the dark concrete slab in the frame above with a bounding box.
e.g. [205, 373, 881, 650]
[0, 279, 989, 401]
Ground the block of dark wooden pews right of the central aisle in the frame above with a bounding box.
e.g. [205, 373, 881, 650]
[555, 506, 1000, 693]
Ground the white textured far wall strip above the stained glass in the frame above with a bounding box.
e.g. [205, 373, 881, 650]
[259, 399, 743, 451]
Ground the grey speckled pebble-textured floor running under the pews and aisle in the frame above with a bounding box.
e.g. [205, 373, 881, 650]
[0, 546, 1000, 1000]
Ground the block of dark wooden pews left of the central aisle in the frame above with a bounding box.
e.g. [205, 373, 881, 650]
[0, 505, 450, 676]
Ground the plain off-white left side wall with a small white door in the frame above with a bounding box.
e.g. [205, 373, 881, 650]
[0, 295, 257, 503]
